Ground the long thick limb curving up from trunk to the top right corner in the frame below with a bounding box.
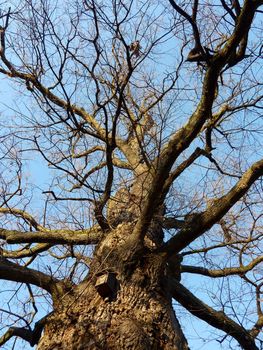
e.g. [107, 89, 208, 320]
[131, 0, 263, 244]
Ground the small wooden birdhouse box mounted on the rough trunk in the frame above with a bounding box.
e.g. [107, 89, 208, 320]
[95, 272, 118, 299]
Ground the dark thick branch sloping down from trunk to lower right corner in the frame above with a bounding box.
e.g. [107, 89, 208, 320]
[171, 279, 258, 350]
